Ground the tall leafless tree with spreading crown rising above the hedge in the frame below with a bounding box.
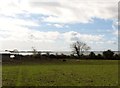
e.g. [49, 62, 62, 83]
[71, 41, 90, 57]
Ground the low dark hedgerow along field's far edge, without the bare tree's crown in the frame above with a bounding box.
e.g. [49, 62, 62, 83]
[21, 50, 120, 60]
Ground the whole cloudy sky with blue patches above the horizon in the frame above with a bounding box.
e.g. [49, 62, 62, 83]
[0, 0, 118, 51]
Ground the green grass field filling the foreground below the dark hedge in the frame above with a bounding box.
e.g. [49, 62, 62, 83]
[2, 60, 118, 86]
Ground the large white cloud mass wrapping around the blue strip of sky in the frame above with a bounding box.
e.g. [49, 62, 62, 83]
[0, 0, 118, 50]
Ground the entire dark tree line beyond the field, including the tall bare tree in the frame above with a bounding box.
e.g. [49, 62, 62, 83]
[9, 41, 120, 60]
